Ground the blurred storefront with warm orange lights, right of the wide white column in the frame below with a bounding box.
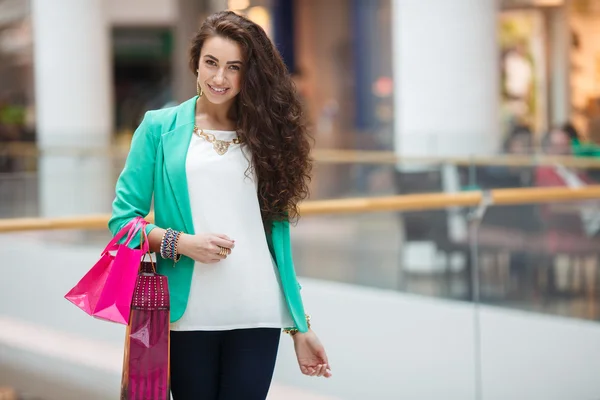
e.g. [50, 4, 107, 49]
[498, 0, 600, 144]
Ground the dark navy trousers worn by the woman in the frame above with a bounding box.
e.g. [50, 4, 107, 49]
[171, 328, 281, 400]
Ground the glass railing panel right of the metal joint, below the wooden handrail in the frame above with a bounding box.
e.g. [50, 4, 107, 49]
[477, 201, 600, 321]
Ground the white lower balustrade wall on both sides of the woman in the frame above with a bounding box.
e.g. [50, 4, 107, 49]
[0, 233, 600, 400]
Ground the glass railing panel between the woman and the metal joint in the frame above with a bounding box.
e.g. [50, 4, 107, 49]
[292, 209, 472, 300]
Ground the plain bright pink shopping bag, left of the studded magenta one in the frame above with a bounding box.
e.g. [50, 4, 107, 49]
[65, 217, 149, 325]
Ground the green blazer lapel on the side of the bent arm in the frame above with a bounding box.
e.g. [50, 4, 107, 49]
[162, 97, 197, 235]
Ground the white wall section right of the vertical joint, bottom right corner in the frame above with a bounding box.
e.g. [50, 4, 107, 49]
[481, 307, 600, 400]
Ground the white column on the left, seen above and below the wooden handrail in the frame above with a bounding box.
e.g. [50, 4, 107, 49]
[31, 0, 114, 216]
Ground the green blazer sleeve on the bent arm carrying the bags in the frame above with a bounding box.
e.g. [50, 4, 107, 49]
[108, 112, 158, 243]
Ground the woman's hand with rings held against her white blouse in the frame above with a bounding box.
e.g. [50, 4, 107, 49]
[177, 233, 235, 264]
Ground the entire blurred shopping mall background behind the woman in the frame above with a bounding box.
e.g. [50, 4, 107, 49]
[0, 0, 600, 400]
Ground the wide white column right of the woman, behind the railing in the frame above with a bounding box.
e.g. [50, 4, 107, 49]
[392, 0, 501, 156]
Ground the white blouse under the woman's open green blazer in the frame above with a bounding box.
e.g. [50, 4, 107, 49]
[171, 130, 294, 331]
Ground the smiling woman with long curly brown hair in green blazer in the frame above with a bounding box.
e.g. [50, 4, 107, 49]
[109, 12, 331, 400]
